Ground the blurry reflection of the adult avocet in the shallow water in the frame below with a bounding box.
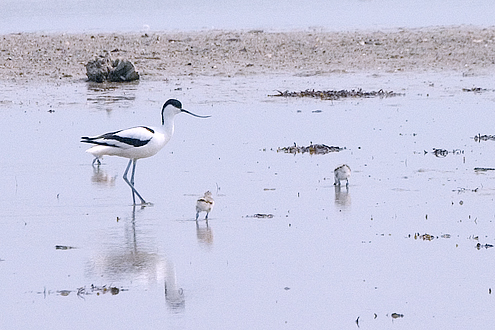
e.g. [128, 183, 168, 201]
[86, 206, 185, 312]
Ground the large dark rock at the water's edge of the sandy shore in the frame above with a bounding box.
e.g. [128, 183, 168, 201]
[86, 54, 139, 83]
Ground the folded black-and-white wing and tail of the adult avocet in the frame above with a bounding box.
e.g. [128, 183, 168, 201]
[81, 126, 155, 149]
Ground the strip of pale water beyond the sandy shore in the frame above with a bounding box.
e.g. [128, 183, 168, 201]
[0, 0, 495, 33]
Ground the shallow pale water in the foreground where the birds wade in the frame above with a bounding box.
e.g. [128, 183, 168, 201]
[0, 73, 495, 329]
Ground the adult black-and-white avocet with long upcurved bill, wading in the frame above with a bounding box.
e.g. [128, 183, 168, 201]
[81, 99, 210, 204]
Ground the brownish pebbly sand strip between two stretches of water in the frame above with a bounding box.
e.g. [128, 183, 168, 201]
[0, 27, 495, 81]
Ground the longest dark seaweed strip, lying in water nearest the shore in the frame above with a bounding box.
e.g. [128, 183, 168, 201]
[268, 88, 404, 100]
